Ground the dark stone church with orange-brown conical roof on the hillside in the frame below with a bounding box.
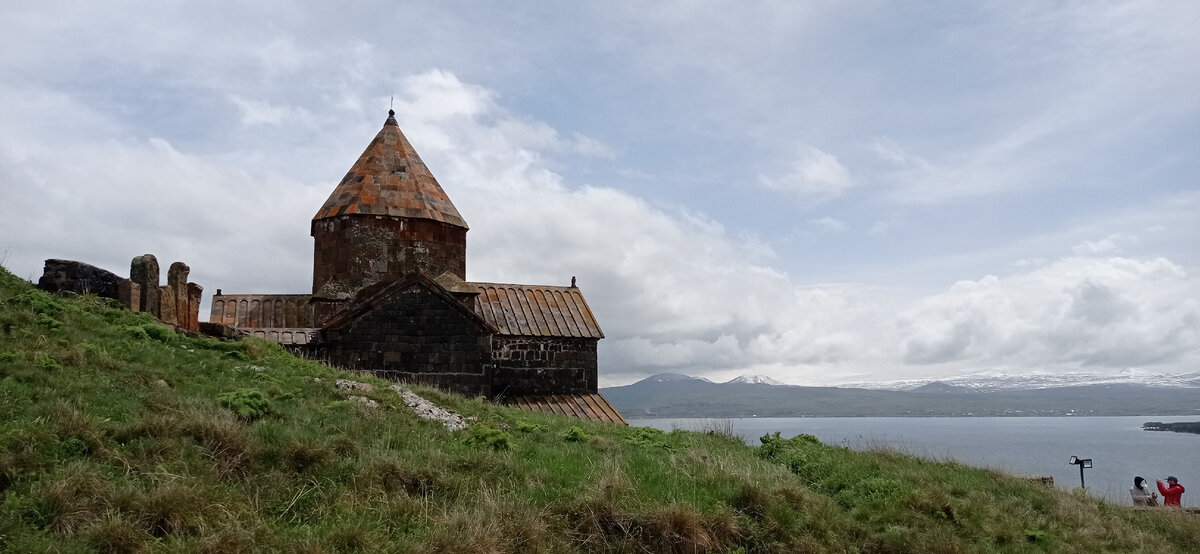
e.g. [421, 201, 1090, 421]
[209, 110, 625, 423]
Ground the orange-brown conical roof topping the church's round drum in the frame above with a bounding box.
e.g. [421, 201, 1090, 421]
[312, 110, 468, 229]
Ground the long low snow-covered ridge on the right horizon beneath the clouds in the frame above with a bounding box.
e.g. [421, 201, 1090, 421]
[839, 369, 1200, 392]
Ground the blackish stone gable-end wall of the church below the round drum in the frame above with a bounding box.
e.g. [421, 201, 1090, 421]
[314, 287, 492, 396]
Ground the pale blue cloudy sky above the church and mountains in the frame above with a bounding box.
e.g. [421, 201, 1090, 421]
[0, 0, 1200, 386]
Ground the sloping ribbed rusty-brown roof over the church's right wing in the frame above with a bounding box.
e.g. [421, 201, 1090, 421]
[468, 283, 604, 338]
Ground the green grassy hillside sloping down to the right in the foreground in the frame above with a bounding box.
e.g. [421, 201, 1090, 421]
[0, 269, 1200, 553]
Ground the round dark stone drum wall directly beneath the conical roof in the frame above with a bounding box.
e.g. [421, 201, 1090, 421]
[312, 216, 467, 300]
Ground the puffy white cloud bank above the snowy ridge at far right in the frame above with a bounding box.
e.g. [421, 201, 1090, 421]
[898, 257, 1200, 369]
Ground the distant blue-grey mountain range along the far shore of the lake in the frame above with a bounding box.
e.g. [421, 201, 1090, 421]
[600, 373, 1200, 418]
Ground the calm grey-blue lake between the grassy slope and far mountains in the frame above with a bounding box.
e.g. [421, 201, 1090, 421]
[629, 416, 1200, 506]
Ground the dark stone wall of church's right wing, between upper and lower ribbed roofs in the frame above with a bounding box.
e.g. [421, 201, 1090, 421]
[492, 335, 596, 396]
